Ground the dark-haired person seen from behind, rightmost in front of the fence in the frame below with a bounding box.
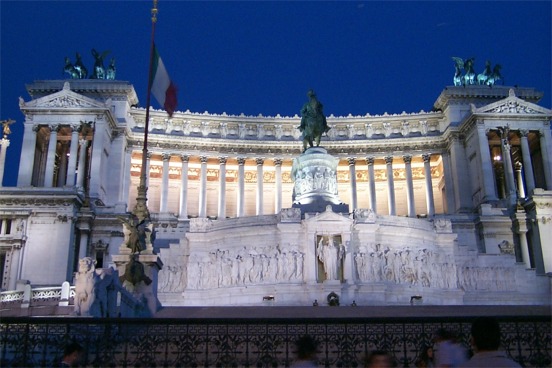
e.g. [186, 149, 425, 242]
[462, 317, 521, 368]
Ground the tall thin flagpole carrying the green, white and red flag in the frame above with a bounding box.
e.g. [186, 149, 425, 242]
[133, 0, 158, 222]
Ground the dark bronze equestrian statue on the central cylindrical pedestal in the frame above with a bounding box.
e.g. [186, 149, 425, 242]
[298, 90, 331, 152]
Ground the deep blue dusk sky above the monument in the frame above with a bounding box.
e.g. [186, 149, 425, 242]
[0, 0, 552, 186]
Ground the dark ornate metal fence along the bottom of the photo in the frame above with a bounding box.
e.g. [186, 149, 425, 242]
[0, 316, 552, 367]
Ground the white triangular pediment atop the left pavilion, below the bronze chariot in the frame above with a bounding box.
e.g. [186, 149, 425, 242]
[21, 83, 106, 110]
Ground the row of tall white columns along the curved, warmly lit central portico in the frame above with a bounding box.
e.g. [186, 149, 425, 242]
[137, 153, 435, 219]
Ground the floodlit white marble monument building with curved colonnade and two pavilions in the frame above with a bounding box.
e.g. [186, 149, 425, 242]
[0, 74, 552, 306]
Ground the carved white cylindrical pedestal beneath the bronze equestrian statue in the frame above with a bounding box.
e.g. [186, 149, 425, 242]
[291, 147, 349, 215]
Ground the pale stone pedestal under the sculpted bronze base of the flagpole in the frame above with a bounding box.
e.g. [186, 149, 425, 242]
[112, 254, 163, 316]
